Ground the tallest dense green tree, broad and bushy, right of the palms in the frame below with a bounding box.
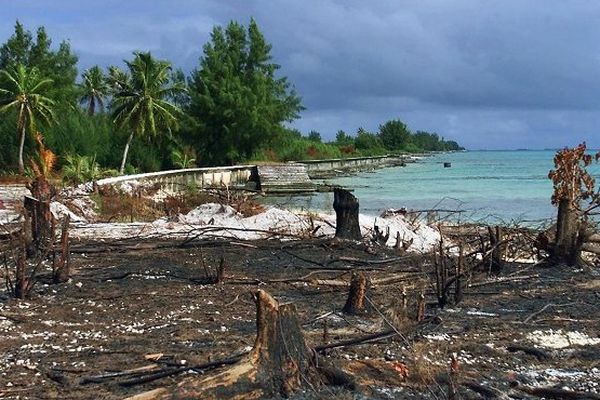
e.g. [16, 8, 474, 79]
[187, 19, 303, 165]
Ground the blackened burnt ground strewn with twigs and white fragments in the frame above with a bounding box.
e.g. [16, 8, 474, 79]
[0, 241, 600, 399]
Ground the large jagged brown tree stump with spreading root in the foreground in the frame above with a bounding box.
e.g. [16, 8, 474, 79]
[158, 290, 321, 399]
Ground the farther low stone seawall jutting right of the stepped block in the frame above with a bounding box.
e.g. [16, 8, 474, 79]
[302, 155, 411, 179]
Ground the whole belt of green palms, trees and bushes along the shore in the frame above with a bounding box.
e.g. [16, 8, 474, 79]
[0, 20, 461, 182]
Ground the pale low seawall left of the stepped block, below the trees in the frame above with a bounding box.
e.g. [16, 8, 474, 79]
[97, 165, 257, 193]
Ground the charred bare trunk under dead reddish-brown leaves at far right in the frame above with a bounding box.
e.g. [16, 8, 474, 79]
[553, 199, 580, 265]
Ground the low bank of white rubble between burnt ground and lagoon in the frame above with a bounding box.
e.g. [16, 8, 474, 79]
[71, 203, 440, 252]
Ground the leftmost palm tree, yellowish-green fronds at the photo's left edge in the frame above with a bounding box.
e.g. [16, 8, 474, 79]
[0, 64, 55, 174]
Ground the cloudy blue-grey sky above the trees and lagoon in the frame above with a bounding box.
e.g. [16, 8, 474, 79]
[0, 0, 600, 149]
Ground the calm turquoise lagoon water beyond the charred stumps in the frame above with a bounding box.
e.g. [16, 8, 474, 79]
[267, 150, 600, 224]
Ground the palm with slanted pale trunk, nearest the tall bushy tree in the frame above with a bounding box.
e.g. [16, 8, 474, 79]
[112, 52, 185, 173]
